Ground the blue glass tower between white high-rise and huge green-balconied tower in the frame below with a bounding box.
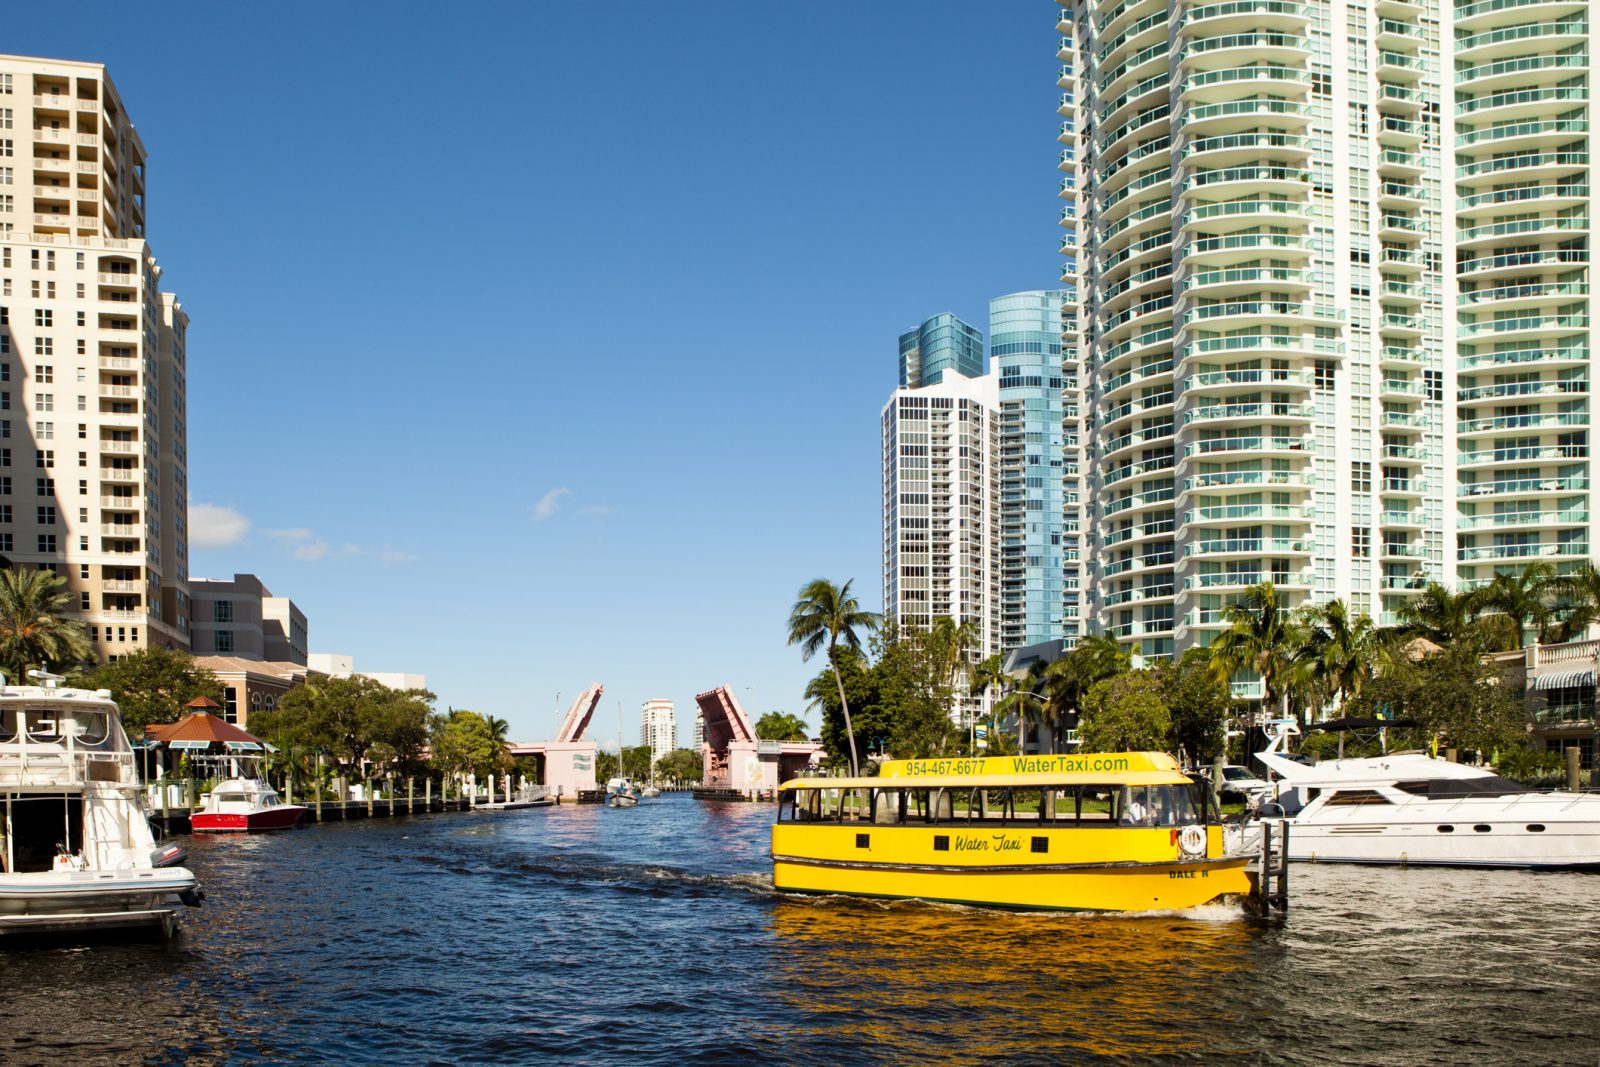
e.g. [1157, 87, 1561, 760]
[989, 291, 1077, 651]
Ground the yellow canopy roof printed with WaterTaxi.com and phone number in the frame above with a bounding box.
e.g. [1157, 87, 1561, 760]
[782, 752, 1192, 789]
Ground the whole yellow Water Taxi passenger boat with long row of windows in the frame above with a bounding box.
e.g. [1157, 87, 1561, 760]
[773, 752, 1261, 912]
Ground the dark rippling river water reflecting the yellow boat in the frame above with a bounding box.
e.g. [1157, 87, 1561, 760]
[0, 795, 1600, 1065]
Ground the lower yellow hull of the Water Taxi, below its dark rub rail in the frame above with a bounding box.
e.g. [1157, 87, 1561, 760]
[773, 856, 1254, 912]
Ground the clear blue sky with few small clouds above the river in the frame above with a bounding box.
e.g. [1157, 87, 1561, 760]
[12, 0, 1059, 744]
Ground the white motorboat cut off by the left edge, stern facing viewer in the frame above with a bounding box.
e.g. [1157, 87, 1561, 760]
[0, 672, 203, 934]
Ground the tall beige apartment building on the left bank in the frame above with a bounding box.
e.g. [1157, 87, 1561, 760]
[0, 56, 189, 661]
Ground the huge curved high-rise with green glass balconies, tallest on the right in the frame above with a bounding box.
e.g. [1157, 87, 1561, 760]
[1058, 0, 1594, 671]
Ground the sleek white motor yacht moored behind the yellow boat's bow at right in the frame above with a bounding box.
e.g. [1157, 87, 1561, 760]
[1246, 725, 1600, 867]
